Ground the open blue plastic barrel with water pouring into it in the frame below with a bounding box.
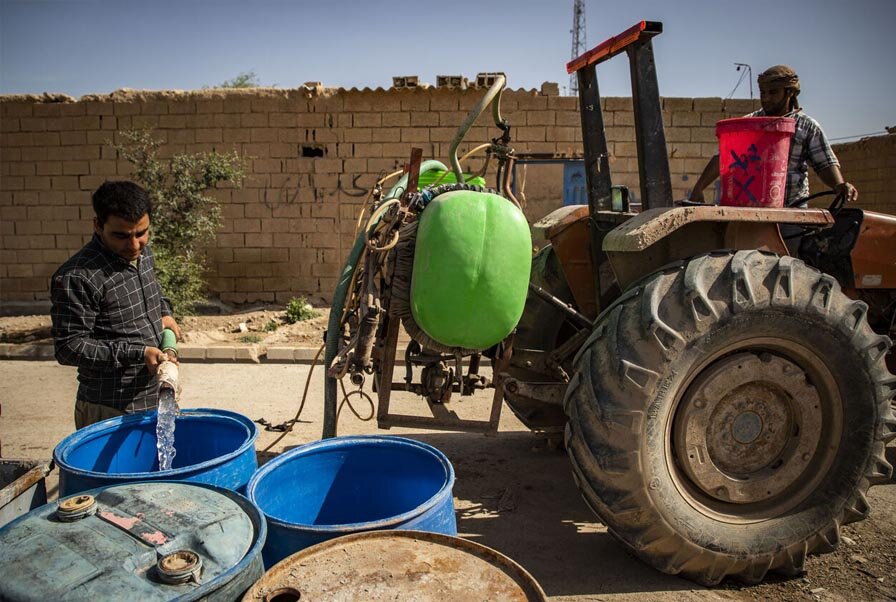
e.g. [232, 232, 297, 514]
[53, 409, 258, 497]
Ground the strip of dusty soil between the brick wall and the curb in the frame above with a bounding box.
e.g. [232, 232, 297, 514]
[0, 307, 330, 347]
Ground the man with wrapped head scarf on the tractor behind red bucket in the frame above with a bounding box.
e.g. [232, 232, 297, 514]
[690, 65, 859, 207]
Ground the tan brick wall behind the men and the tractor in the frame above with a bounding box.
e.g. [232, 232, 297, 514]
[10, 84, 860, 309]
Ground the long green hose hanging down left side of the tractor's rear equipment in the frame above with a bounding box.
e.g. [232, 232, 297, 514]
[321, 160, 446, 439]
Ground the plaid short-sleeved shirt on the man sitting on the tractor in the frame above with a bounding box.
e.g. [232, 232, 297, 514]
[747, 109, 840, 205]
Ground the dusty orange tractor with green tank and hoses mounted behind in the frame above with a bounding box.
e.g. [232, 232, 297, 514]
[323, 21, 896, 585]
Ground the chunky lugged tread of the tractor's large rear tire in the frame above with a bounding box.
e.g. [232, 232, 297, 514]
[564, 251, 896, 585]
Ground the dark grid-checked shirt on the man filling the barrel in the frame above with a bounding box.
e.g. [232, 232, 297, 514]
[50, 234, 171, 412]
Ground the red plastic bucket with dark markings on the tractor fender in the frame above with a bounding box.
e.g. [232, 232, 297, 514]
[716, 117, 796, 207]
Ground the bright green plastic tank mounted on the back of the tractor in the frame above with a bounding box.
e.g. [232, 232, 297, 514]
[411, 190, 532, 349]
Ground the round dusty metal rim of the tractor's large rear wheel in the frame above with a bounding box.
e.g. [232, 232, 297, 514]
[673, 352, 821, 504]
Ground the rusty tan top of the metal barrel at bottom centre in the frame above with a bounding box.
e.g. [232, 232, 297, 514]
[243, 531, 546, 602]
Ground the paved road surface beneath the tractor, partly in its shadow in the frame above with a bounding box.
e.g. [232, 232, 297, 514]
[0, 361, 896, 602]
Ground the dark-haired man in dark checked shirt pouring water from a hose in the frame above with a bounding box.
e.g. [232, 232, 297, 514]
[50, 182, 180, 429]
